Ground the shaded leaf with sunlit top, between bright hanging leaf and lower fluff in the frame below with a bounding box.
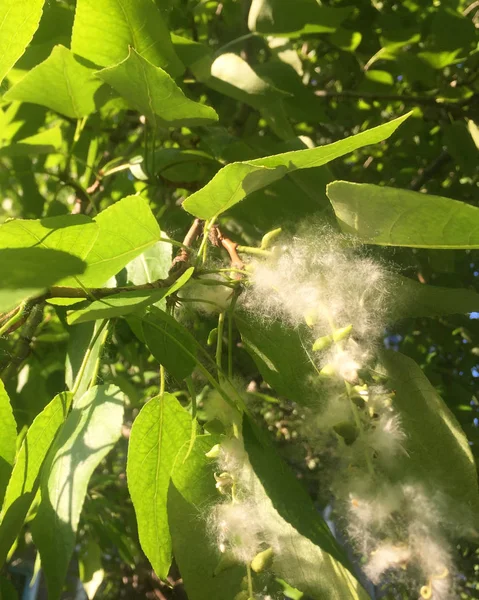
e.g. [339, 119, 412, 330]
[168, 435, 245, 600]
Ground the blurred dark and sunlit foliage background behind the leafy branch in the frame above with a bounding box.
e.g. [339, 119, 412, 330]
[0, 0, 479, 598]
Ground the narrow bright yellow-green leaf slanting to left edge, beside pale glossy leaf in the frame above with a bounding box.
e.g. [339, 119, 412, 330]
[0, 392, 72, 565]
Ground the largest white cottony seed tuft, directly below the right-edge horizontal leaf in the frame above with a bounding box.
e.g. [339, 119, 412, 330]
[242, 227, 390, 342]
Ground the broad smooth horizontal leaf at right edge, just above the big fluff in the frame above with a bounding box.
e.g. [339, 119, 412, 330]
[327, 181, 479, 249]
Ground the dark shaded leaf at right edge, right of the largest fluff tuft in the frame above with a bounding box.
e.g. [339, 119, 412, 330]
[390, 275, 479, 321]
